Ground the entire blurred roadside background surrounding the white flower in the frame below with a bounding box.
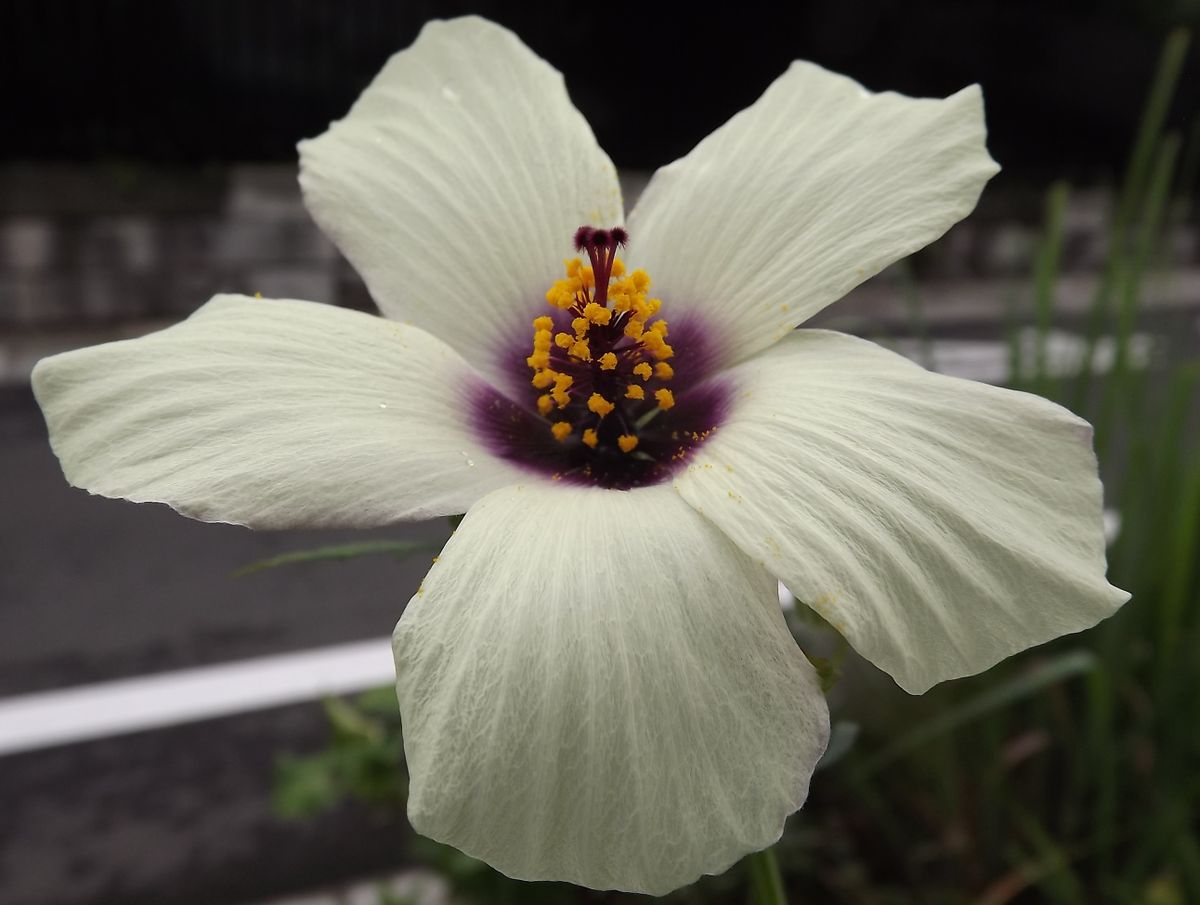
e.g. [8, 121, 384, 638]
[0, 0, 1200, 905]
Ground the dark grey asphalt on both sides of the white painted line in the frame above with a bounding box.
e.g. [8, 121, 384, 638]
[0, 389, 449, 905]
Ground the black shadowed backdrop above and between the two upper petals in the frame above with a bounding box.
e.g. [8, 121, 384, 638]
[7, 0, 1200, 184]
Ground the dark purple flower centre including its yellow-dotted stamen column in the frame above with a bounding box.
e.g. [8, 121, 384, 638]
[475, 226, 728, 490]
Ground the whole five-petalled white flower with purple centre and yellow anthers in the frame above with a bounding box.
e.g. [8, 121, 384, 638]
[34, 18, 1127, 893]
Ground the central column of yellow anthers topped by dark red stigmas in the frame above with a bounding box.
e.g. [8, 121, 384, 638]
[526, 226, 676, 456]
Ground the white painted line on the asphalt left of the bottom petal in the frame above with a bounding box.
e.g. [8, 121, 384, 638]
[0, 639, 395, 755]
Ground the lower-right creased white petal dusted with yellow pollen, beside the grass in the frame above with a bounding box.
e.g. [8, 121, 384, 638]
[676, 330, 1129, 694]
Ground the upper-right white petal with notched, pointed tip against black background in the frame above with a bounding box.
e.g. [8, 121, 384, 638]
[629, 62, 998, 360]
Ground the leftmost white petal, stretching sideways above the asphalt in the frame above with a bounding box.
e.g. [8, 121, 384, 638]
[34, 295, 528, 528]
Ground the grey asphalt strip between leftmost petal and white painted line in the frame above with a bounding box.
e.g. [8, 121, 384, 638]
[0, 389, 449, 696]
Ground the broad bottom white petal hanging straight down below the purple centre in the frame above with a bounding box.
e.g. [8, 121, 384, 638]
[395, 485, 828, 894]
